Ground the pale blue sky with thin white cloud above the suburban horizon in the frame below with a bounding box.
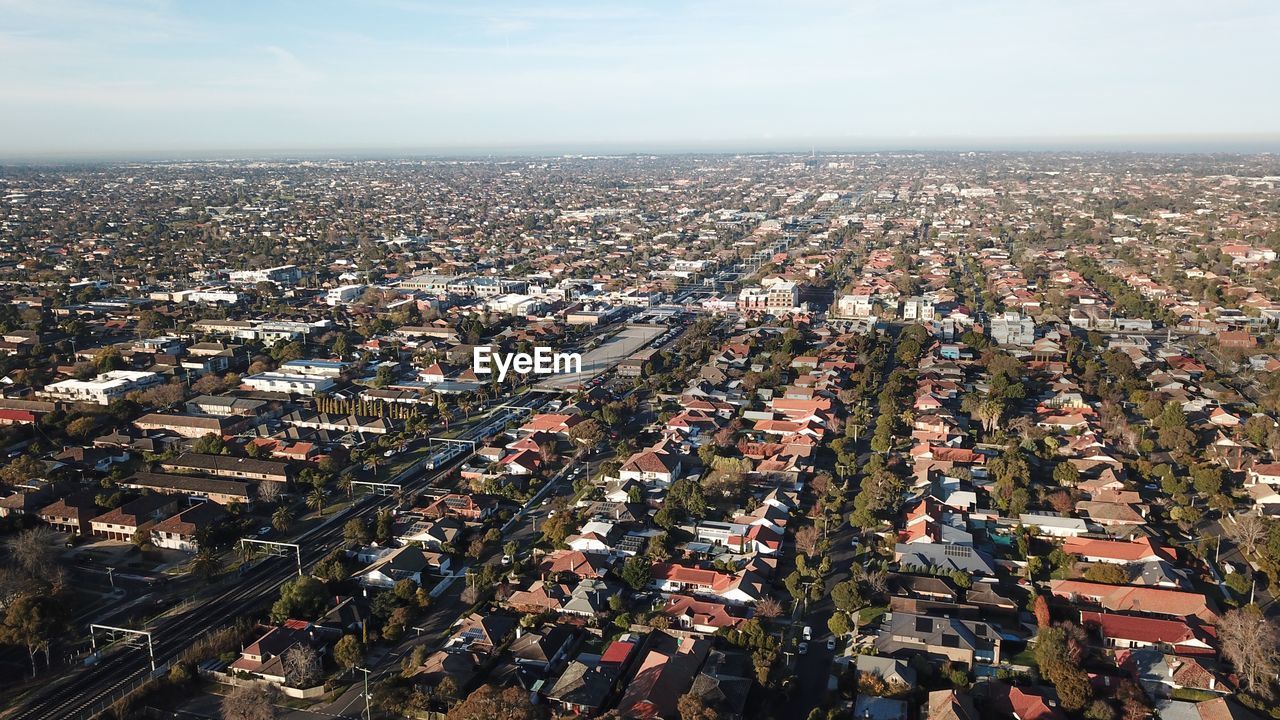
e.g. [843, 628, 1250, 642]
[0, 0, 1280, 158]
